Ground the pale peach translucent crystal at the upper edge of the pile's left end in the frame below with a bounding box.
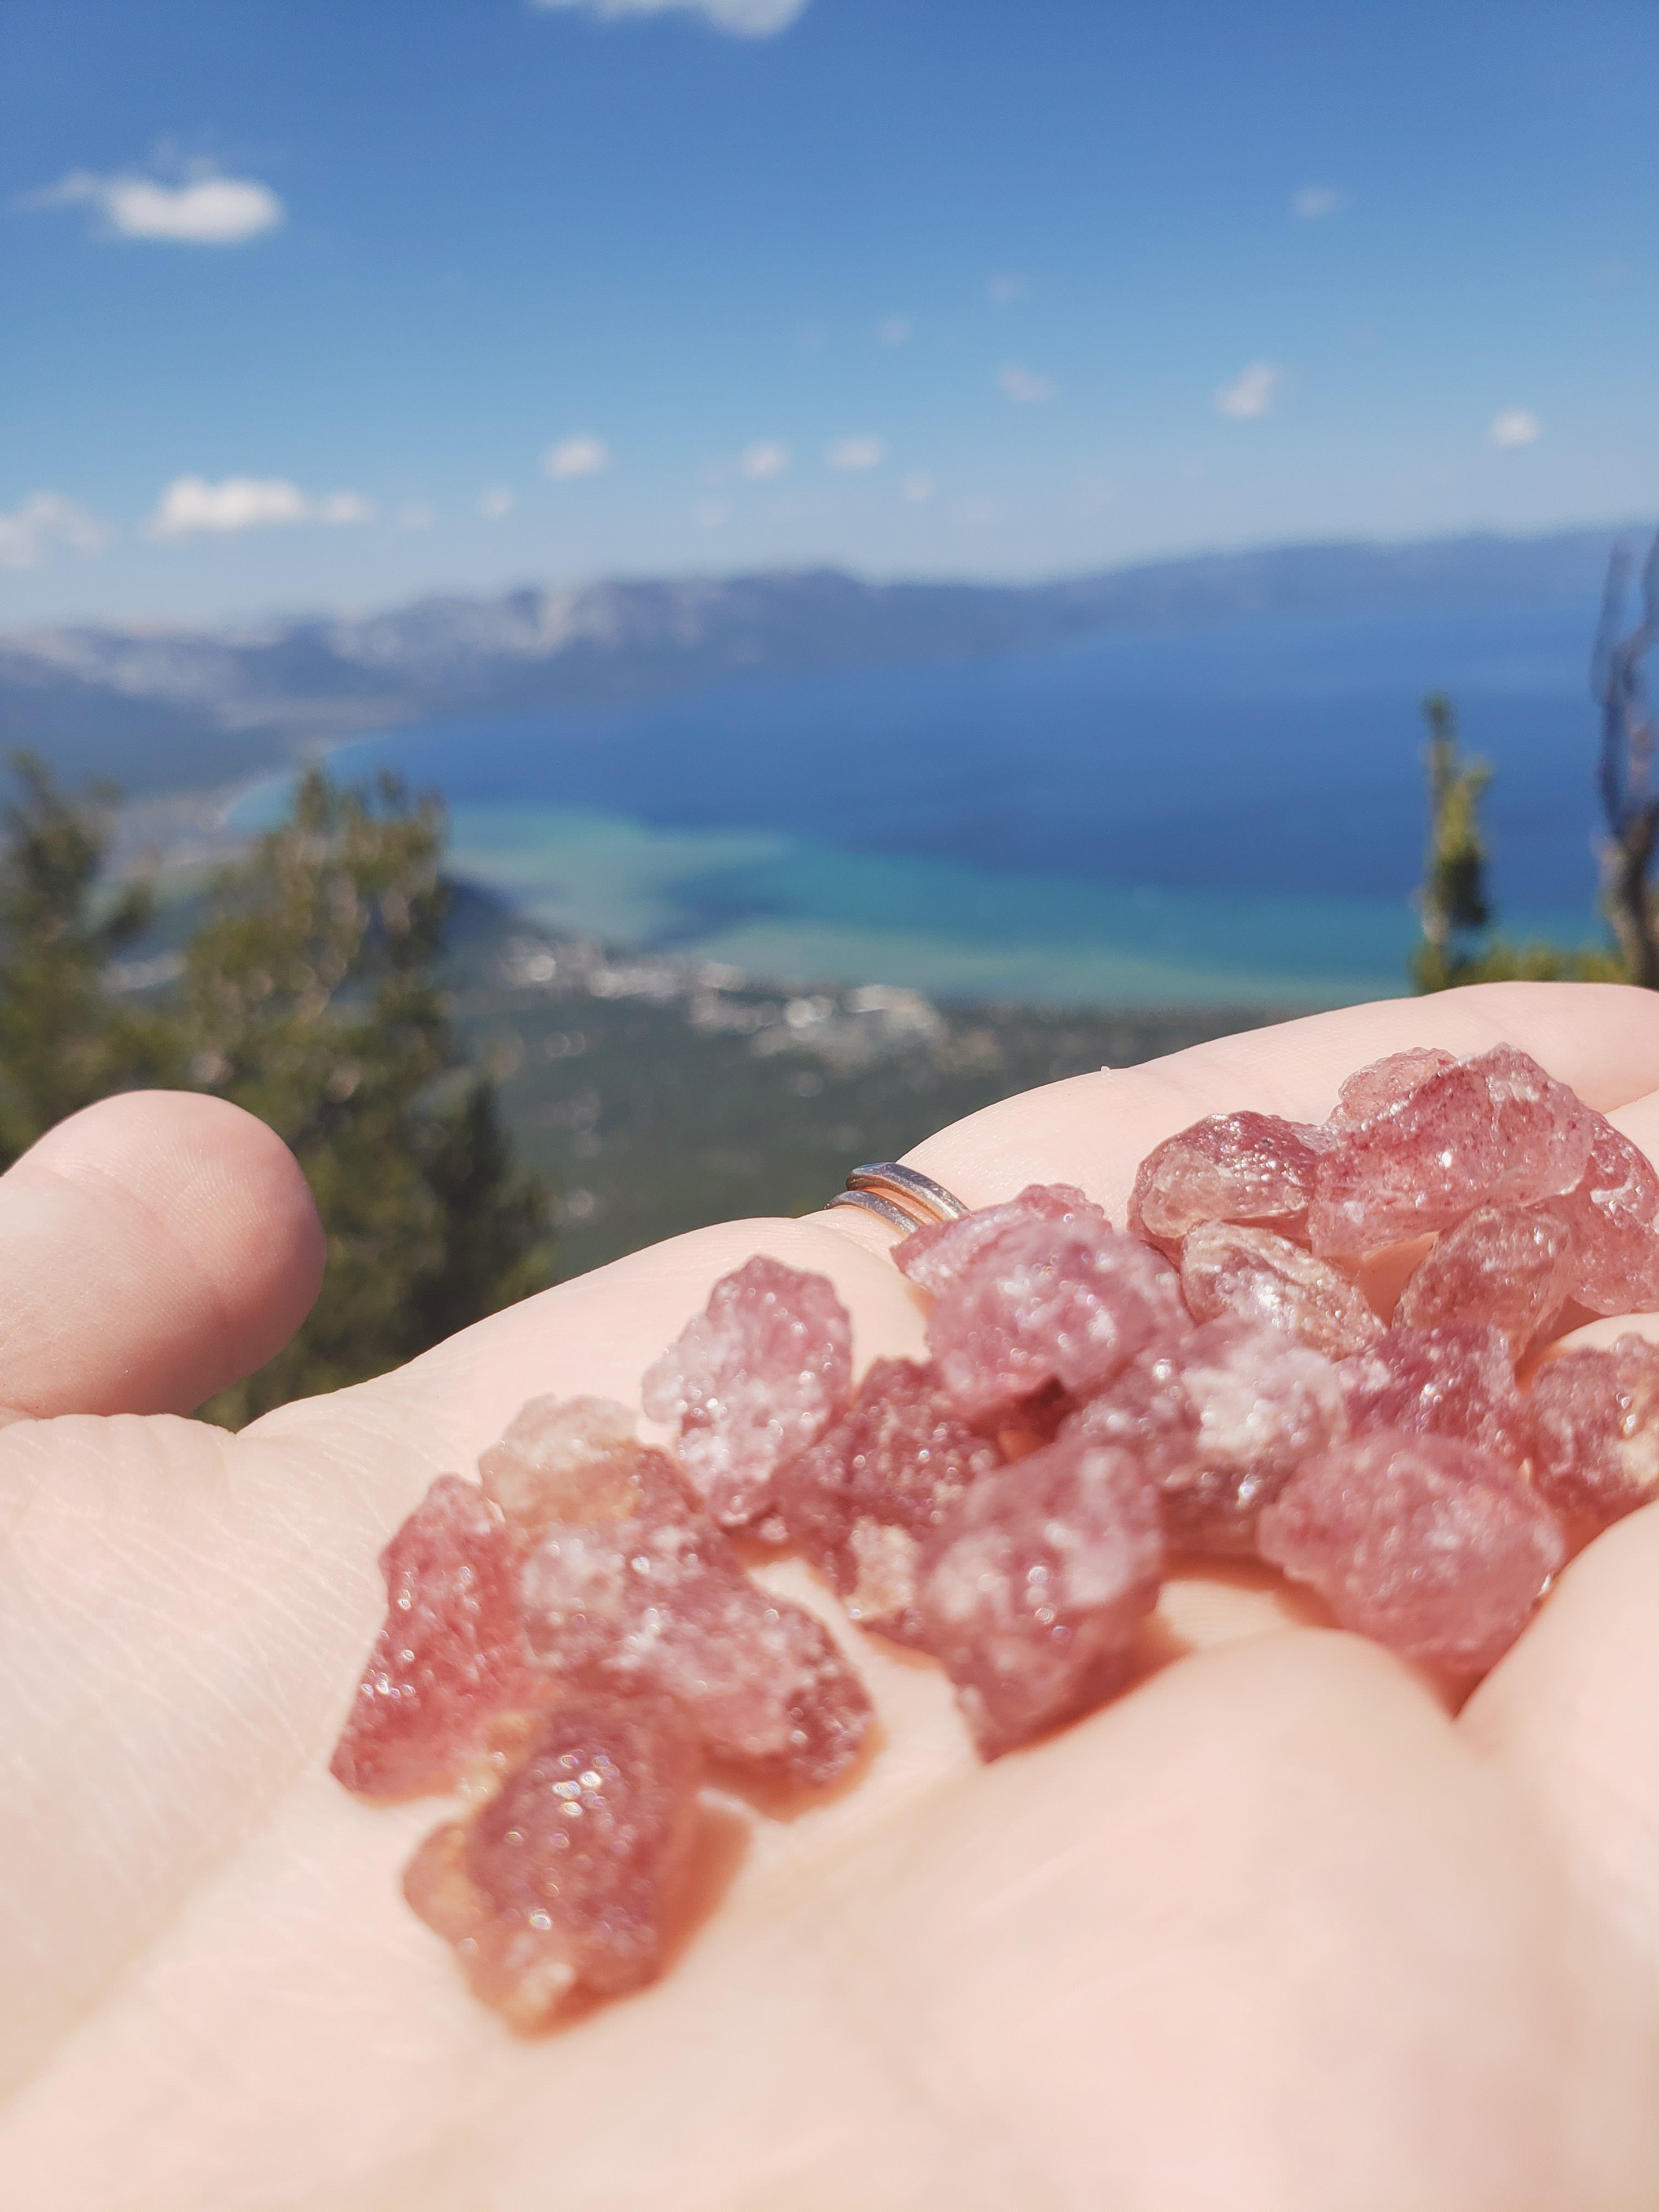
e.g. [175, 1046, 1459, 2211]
[478, 1398, 692, 1539]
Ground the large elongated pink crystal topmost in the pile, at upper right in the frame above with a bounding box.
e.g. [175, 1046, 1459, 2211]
[1307, 1044, 1595, 1256]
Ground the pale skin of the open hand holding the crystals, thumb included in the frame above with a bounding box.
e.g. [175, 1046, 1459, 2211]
[0, 984, 1659, 2212]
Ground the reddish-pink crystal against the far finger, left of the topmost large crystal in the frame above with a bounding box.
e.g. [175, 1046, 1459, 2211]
[1128, 1113, 1321, 1252]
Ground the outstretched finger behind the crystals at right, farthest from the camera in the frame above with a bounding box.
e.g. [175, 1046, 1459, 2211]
[902, 982, 1659, 1234]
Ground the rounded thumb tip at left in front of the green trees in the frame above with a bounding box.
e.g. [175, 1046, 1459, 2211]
[0, 1091, 323, 1415]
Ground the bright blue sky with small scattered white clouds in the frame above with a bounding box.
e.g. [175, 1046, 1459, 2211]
[0, 0, 1659, 626]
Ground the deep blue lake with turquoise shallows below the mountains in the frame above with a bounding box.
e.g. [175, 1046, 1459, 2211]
[236, 597, 1628, 1005]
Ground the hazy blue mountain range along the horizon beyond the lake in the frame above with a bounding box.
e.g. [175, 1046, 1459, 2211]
[0, 529, 1615, 794]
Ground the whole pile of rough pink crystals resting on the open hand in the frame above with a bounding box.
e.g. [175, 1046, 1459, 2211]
[334, 1046, 1659, 2026]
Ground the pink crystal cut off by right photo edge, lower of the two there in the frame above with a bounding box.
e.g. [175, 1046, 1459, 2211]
[1528, 1336, 1659, 1544]
